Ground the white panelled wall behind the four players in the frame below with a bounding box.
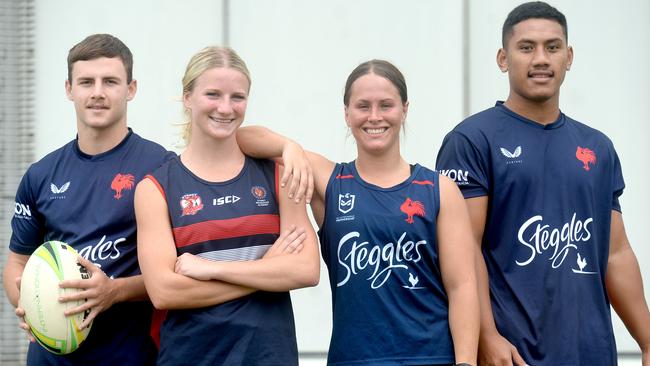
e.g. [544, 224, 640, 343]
[34, 0, 650, 352]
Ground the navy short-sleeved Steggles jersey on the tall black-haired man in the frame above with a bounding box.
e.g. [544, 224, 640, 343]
[436, 102, 624, 366]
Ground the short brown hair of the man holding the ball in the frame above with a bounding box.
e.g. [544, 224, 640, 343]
[68, 34, 133, 84]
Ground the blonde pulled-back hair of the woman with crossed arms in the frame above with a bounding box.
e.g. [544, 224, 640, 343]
[181, 46, 251, 144]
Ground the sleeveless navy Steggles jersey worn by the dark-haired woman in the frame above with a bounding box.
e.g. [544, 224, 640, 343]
[319, 162, 454, 365]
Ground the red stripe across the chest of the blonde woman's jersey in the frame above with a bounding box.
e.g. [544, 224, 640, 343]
[174, 214, 280, 248]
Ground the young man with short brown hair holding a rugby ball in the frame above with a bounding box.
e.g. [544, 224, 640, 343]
[3, 34, 170, 365]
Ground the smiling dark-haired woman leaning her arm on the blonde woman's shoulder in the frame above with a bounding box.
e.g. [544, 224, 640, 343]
[238, 60, 479, 365]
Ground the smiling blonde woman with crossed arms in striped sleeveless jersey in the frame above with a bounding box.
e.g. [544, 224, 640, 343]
[136, 47, 320, 366]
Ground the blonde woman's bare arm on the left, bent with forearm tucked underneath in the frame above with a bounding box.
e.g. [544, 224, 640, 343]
[135, 179, 255, 309]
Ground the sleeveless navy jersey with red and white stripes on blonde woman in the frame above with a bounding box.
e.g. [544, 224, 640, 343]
[150, 157, 298, 366]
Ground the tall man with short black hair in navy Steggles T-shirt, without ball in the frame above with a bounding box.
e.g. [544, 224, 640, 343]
[436, 2, 650, 366]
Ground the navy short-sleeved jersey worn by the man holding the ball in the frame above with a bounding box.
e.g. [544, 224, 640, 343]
[9, 129, 171, 365]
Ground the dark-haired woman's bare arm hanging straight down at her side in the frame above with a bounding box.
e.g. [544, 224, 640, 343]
[437, 176, 479, 365]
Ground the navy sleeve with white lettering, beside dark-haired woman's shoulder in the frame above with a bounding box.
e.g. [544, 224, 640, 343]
[436, 131, 490, 198]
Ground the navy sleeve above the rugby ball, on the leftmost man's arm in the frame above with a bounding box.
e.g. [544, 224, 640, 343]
[9, 170, 44, 255]
